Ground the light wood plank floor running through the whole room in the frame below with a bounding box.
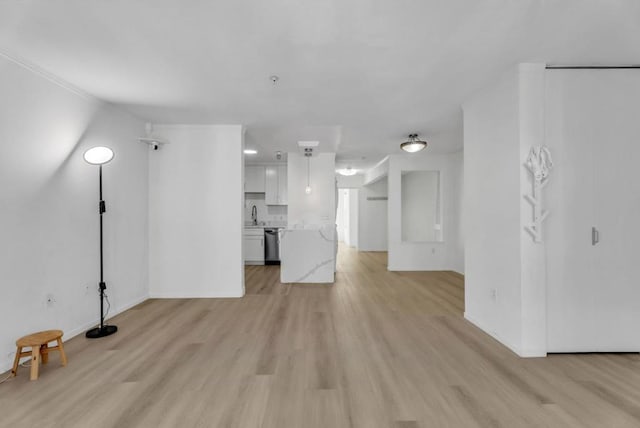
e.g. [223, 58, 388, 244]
[0, 248, 640, 428]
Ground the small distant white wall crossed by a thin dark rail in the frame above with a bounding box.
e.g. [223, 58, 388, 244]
[358, 177, 388, 251]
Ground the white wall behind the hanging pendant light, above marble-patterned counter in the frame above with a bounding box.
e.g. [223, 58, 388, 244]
[287, 153, 336, 228]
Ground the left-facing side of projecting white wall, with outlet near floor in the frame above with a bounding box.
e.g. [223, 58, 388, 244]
[463, 70, 522, 352]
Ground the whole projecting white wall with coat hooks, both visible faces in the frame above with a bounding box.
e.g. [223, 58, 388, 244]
[463, 64, 546, 356]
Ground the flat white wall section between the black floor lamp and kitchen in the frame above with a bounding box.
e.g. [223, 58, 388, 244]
[149, 125, 244, 297]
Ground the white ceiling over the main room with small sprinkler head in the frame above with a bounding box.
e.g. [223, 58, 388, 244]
[0, 0, 640, 170]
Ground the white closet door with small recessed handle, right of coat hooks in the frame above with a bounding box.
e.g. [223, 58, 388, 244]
[545, 71, 640, 352]
